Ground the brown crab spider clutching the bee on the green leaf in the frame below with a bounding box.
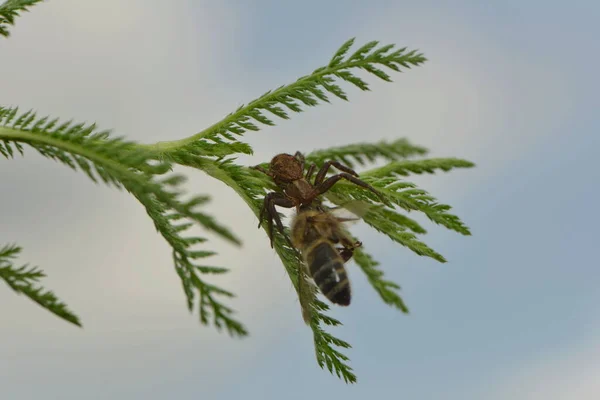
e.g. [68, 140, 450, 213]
[252, 151, 386, 248]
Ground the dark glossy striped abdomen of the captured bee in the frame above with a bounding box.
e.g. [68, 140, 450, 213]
[308, 242, 351, 306]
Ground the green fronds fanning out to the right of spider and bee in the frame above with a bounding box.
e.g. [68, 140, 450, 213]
[306, 151, 474, 313]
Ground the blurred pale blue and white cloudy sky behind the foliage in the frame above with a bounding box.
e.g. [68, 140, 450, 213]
[0, 0, 600, 400]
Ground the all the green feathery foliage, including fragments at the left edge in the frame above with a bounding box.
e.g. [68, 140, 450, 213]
[0, 6, 473, 383]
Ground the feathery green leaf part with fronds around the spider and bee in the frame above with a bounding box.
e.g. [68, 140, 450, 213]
[173, 133, 468, 383]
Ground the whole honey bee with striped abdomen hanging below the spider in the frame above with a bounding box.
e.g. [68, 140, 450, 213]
[291, 206, 362, 306]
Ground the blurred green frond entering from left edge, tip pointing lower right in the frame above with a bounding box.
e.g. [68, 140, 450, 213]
[0, 107, 241, 244]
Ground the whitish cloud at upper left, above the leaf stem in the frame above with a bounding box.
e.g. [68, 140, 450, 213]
[0, 0, 244, 142]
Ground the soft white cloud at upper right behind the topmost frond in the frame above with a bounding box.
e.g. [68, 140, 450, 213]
[248, 6, 574, 195]
